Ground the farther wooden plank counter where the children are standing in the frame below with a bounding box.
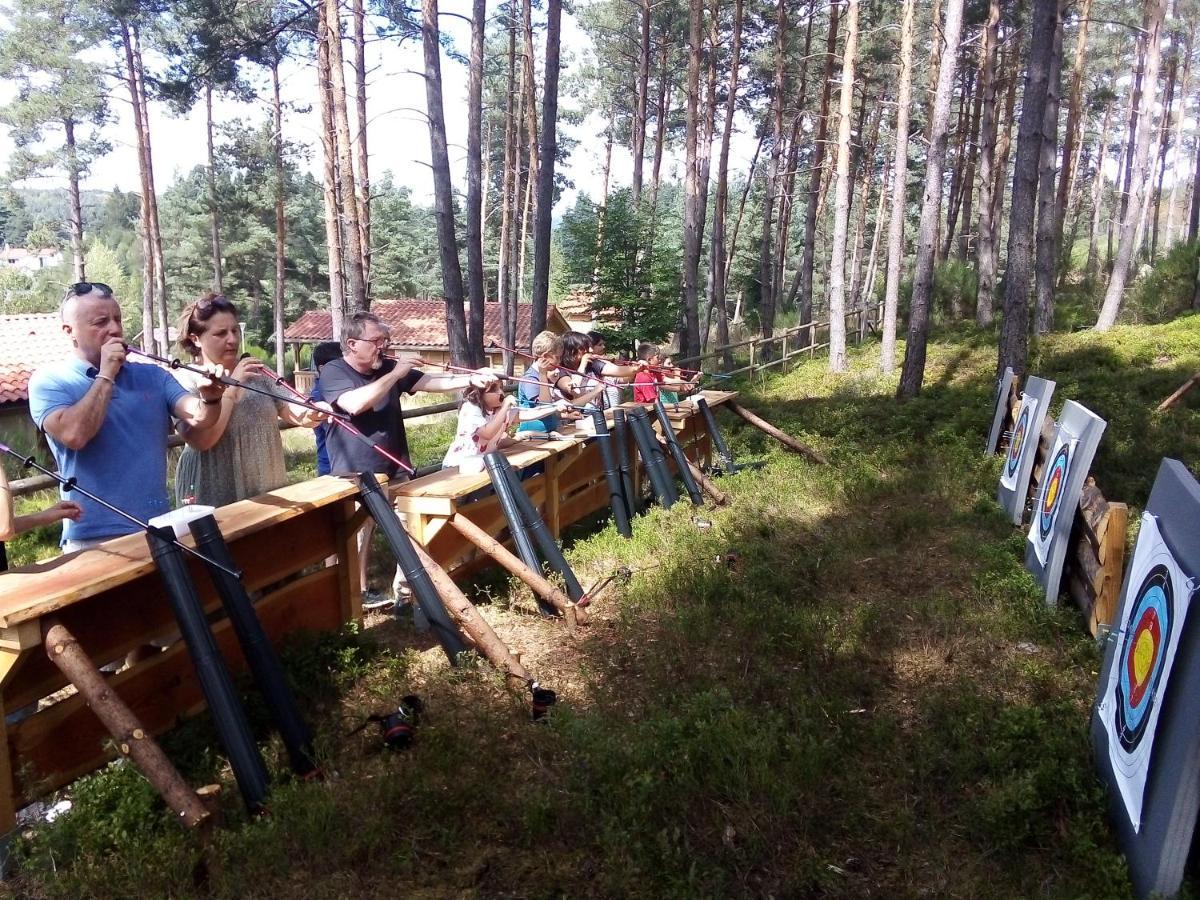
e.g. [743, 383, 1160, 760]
[394, 390, 737, 574]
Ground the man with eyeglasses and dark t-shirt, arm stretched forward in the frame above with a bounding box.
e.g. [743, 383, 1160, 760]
[320, 312, 496, 610]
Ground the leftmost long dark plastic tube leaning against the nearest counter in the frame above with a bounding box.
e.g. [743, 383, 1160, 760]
[146, 527, 268, 812]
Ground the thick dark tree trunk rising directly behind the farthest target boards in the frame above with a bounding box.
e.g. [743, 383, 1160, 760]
[996, 0, 1058, 374]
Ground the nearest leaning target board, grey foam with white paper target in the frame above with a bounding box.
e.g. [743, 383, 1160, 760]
[1092, 460, 1200, 896]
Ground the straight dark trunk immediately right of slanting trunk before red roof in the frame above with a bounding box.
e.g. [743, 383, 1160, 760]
[465, 0, 487, 366]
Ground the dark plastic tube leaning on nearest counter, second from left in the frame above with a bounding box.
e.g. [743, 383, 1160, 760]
[188, 516, 318, 778]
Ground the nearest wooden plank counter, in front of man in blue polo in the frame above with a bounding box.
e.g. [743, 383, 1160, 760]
[0, 476, 362, 834]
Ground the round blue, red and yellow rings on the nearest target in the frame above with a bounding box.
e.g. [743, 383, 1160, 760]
[1115, 564, 1175, 754]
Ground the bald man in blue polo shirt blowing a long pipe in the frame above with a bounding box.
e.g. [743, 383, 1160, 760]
[29, 282, 224, 553]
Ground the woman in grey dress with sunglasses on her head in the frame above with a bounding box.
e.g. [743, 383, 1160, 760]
[175, 294, 322, 506]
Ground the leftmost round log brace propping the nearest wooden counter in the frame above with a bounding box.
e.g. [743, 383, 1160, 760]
[46, 623, 209, 828]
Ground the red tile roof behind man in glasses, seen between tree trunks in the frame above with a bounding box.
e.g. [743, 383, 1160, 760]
[283, 300, 569, 349]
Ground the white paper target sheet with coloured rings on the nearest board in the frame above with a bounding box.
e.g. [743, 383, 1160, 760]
[1099, 512, 1190, 832]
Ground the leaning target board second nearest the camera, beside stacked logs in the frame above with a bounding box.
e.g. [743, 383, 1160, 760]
[1025, 400, 1108, 604]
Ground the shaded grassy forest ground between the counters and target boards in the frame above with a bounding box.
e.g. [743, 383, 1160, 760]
[11, 317, 1200, 898]
